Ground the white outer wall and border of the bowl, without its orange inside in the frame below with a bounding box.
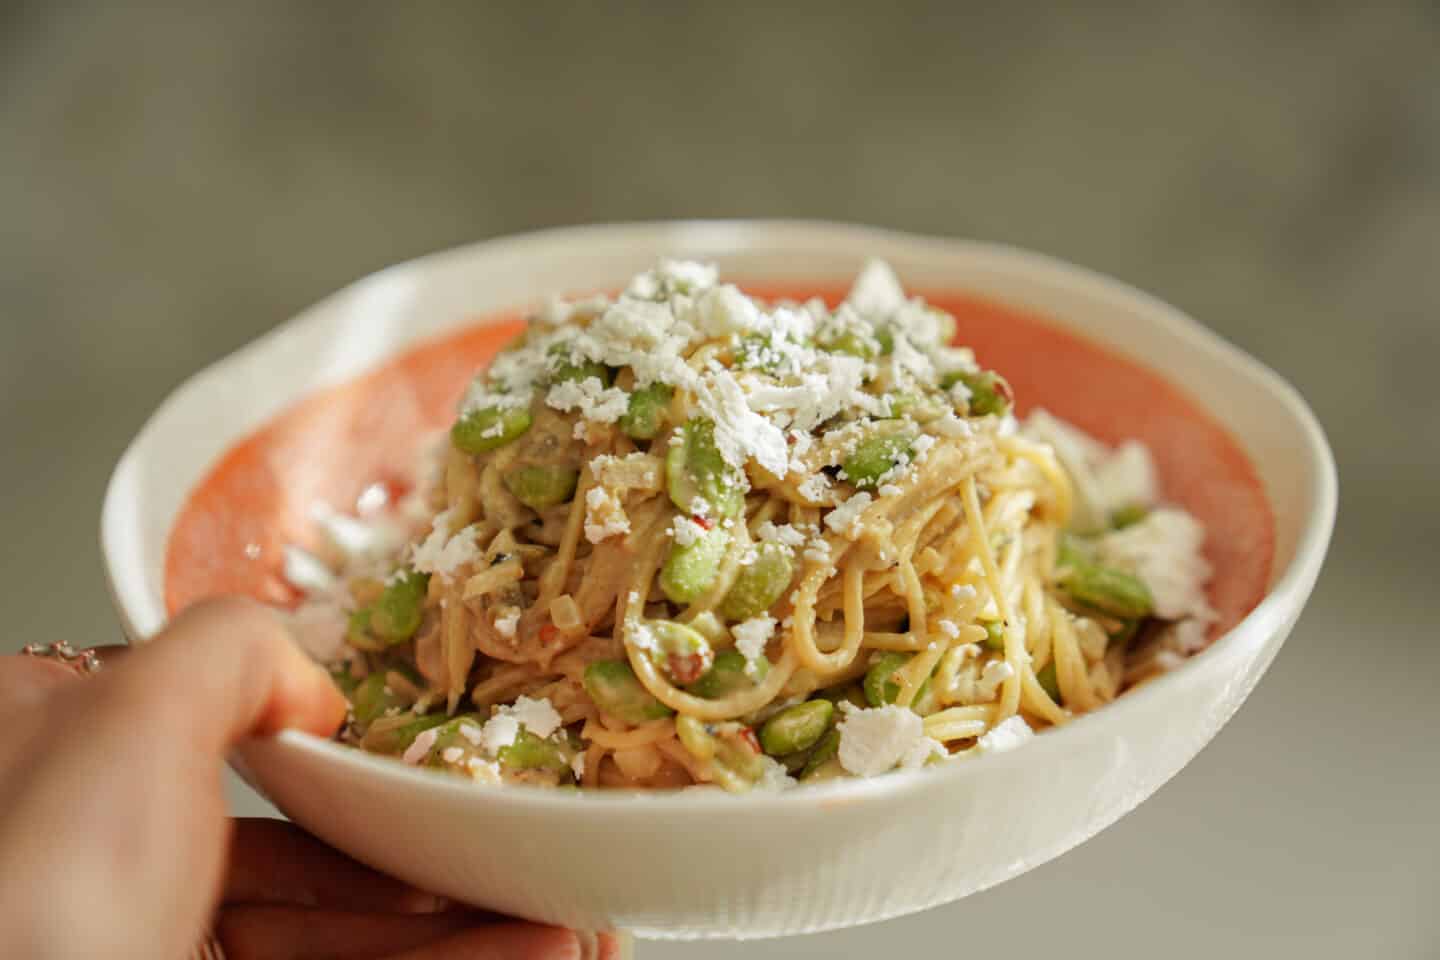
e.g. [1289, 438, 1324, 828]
[101, 222, 1336, 938]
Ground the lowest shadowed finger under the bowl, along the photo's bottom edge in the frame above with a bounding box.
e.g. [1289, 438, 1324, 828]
[215, 904, 485, 960]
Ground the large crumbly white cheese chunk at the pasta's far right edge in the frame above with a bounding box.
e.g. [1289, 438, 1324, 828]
[1096, 507, 1215, 620]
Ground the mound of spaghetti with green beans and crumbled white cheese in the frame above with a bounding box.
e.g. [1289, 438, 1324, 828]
[275, 262, 1214, 792]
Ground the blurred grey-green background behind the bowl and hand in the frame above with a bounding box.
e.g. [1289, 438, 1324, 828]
[0, 0, 1440, 960]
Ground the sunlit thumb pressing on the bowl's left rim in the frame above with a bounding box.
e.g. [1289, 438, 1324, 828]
[95, 597, 346, 754]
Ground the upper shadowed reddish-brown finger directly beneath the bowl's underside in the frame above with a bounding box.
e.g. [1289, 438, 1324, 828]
[223, 819, 445, 914]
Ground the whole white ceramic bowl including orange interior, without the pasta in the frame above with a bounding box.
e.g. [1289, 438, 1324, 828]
[101, 220, 1336, 938]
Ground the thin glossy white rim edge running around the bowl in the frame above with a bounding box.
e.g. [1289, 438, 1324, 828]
[99, 219, 1338, 816]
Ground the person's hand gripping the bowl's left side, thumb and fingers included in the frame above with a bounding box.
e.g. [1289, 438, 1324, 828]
[0, 600, 618, 960]
